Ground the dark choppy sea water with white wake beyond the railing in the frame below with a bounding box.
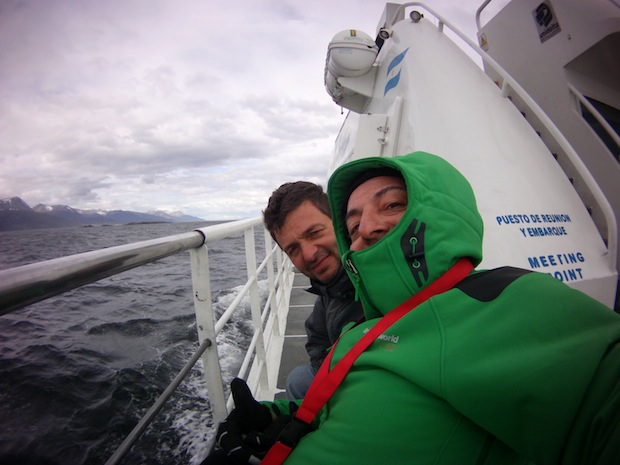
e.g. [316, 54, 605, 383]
[0, 223, 264, 465]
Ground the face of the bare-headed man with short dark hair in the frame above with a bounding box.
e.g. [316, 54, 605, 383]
[275, 200, 340, 283]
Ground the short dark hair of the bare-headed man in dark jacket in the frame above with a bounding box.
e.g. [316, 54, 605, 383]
[263, 181, 332, 242]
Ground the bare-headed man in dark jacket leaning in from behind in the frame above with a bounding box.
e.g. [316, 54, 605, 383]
[263, 181, 362, 399]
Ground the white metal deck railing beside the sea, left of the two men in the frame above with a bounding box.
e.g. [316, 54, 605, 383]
[0, 217, 294, 465]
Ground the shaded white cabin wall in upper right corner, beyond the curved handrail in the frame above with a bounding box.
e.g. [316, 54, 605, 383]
[481, 0, 620, 276]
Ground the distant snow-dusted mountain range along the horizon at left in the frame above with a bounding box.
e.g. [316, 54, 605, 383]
[0, 197, 204, 231]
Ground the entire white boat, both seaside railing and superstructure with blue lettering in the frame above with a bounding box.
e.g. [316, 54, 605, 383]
[0, 0, 620, 465]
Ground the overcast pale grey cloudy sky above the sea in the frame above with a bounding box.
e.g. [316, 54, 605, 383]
[0, 0, 494, 220]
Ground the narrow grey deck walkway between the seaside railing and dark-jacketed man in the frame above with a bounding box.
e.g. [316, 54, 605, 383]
[275, 270, 317, 399]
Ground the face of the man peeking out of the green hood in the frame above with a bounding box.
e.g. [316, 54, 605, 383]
[345, 176, 407, 250]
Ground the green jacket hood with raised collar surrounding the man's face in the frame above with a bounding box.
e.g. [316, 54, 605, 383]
[328, 152, 483, 319]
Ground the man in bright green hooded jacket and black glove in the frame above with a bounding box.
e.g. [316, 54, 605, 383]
[205, 152, 620, 465]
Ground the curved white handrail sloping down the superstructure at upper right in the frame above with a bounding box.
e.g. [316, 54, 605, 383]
[385, 0, 618, 270]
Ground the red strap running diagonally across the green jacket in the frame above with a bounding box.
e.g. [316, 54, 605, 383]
[261, 258, 474, 465]
